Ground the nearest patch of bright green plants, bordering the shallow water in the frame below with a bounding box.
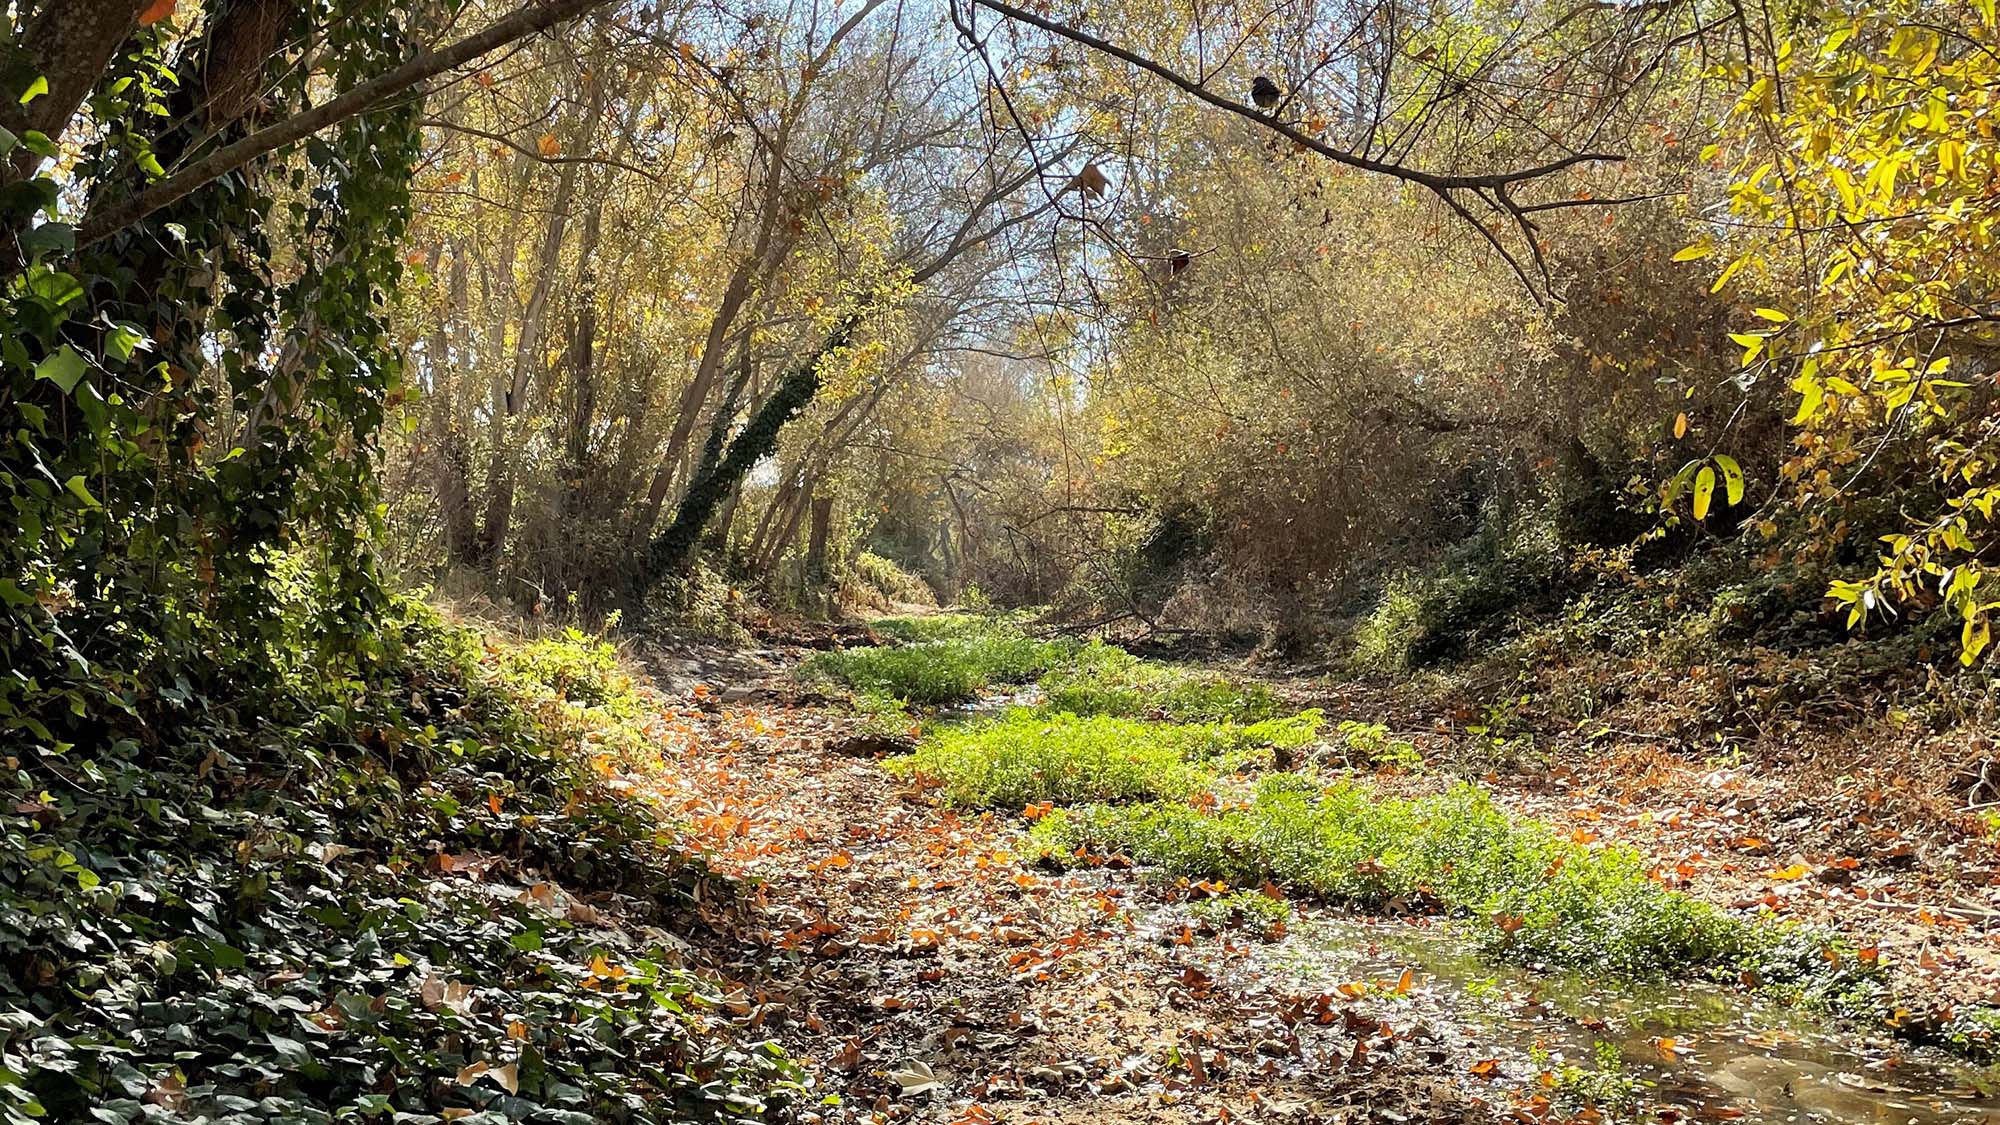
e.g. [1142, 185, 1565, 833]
[1034, 773, 1832, 975]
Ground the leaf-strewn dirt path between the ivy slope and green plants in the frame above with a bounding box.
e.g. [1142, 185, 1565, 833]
[626, 659, 1488, 1125]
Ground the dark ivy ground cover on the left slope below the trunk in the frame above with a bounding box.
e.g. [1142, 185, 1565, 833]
[0, 588, 796, 1125]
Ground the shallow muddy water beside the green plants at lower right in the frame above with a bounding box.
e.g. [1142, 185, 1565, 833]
[1218, 915, 2000, 1125]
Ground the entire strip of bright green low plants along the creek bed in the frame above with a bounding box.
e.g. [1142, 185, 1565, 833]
[864, 623, 1992, 1055]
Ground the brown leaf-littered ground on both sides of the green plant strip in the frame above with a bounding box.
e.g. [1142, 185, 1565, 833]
[604, 635, 2000, 1123]
